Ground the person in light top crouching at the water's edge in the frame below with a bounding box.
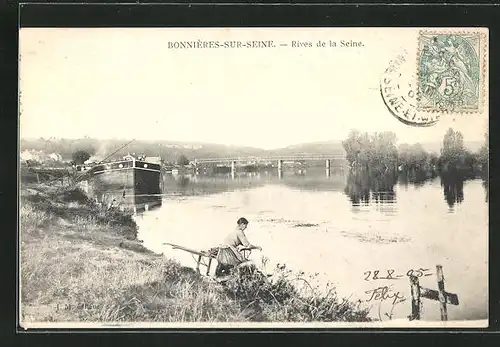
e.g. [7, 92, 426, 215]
[215, 217, 262, 276]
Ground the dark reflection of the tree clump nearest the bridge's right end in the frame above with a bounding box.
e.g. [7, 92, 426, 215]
[344, 170, 397, 206]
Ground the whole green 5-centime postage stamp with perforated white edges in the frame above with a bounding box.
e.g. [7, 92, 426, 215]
[417, 30, 487, 113]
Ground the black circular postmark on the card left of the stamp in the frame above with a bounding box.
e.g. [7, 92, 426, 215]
[380, 52, 439, 126]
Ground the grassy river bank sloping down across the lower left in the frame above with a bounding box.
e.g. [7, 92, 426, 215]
[20, 185, 368, 322]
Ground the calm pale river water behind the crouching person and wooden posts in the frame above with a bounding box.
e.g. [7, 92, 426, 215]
[131, 170, 488, 320]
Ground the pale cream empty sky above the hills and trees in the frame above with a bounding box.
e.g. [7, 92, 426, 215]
[19, 28, 488, 149]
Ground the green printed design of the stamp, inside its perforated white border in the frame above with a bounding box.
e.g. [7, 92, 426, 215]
[418, 34, 480, 112]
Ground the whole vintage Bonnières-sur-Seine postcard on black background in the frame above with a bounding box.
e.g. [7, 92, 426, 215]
[19, 28, 489, 329]
